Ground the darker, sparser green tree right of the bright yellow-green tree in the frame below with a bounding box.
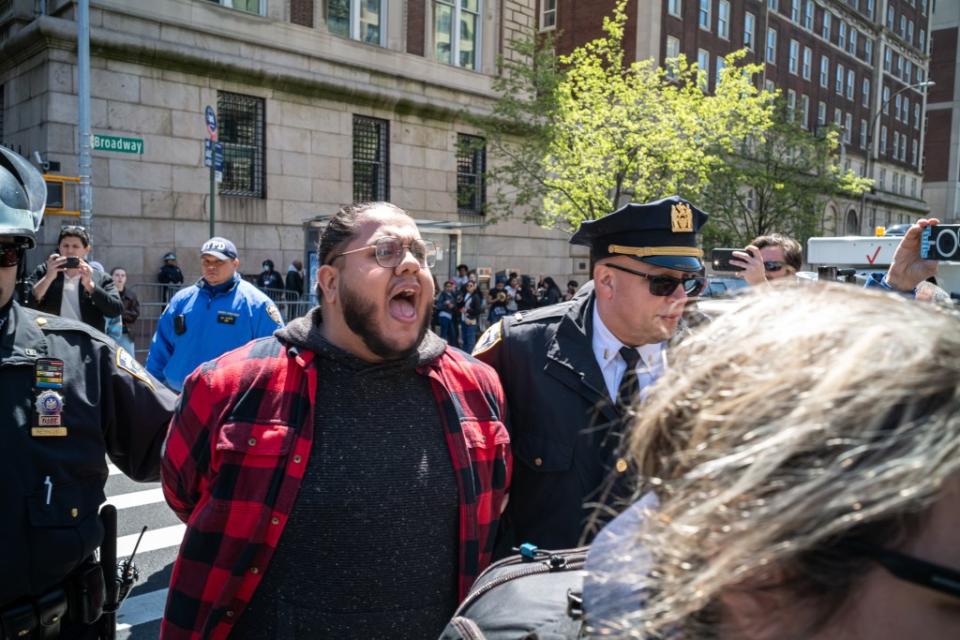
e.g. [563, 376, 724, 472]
[704, 108, 871, 249]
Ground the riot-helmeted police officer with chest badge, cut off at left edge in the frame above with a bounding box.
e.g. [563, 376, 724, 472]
[0, 147, 176, 640]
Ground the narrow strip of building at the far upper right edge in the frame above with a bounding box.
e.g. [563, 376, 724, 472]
[924, 0, 960, 223]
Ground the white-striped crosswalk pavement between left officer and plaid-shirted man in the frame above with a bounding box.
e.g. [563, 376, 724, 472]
[106, 465, 184, 640]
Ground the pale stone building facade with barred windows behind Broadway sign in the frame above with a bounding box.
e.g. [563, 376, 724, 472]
[0, 0, 585, 290]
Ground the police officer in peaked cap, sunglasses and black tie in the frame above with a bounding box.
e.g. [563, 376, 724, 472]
[473, 197, 707, 556]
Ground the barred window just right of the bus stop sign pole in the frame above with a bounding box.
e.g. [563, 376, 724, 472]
[217, 91, 267, 198]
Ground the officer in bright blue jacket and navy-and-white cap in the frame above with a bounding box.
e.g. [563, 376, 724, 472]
[147, 237, 283, 391]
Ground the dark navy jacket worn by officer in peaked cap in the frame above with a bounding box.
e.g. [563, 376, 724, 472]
[473, 283, 626, 557]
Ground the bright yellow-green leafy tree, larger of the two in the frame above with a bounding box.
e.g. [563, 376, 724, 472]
[484, 0, 773, 229]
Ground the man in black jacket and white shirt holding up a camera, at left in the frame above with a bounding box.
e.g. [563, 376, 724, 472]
[27, 225, 123, 331]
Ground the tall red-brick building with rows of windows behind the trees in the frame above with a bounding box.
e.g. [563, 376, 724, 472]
[537, 0, 928, 235]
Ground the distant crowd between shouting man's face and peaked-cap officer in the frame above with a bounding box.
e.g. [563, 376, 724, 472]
[432, 264, 580, 353]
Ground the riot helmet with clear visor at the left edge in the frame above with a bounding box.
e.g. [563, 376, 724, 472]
[0, 146, 47, 248]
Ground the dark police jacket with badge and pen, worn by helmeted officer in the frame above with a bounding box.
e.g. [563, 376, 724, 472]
[0, 302, 176, 609]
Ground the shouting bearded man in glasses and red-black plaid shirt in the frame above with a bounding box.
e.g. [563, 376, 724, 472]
[161, 202, 511, 639]
